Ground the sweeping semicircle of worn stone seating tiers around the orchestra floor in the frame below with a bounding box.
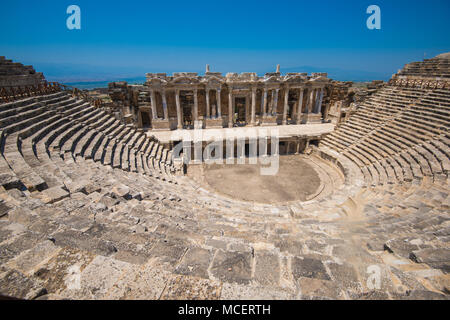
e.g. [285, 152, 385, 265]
[0, 69, 449, 298]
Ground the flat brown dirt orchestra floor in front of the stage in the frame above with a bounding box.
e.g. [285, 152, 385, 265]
[199, 156, 320, 203]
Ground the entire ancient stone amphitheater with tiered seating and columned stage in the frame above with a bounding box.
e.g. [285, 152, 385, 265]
[0, 54, 450, 300]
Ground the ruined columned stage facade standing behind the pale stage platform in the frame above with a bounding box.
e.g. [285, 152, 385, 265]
[109, 65, 333, 131]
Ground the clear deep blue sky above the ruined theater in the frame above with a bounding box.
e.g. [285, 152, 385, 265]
[0, 0, 450, 79]
